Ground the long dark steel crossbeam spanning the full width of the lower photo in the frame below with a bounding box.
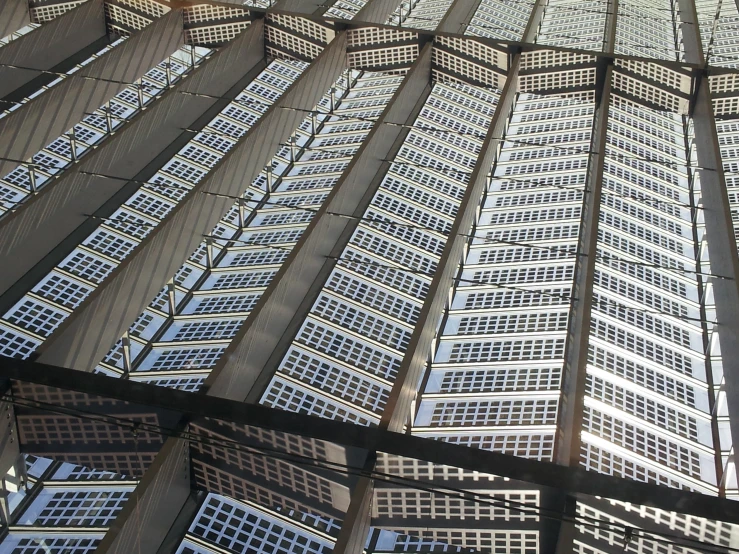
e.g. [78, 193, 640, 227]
[0, 357, 739, 523]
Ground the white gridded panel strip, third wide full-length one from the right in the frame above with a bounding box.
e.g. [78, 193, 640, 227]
[262, 78, 498, 424]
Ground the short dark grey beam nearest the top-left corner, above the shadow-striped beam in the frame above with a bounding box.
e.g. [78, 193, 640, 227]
[0, 0, 107, 98]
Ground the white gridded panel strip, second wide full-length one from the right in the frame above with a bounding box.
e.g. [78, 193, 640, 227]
[414, 94, 594, 459]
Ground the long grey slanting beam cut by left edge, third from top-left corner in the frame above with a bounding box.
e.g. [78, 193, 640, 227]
[0, 20, 266, 312]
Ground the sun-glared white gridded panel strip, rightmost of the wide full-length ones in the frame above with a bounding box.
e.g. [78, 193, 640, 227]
[582, 97, 716, 492]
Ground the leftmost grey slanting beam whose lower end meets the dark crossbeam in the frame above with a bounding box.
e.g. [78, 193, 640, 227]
[39, 33, 346, 371]
